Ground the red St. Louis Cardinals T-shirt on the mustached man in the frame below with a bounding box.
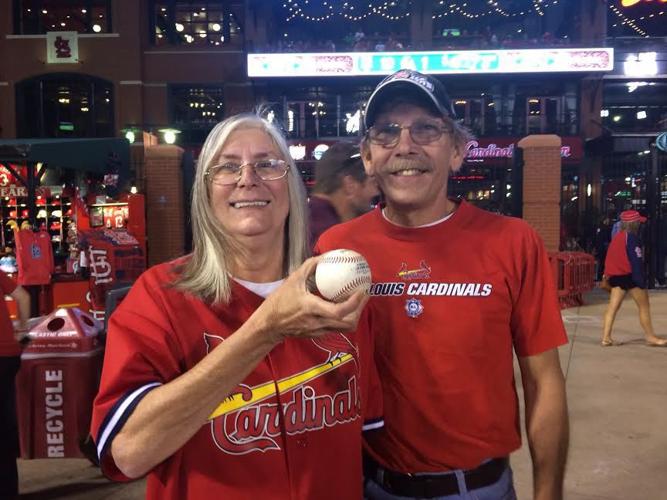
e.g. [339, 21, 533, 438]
[316, 201, 567, 473]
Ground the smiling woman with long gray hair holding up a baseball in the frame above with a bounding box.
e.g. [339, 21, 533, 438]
[92, 115, 378, 499]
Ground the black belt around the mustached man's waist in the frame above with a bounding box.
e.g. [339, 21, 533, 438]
[364, 457, 509, 498]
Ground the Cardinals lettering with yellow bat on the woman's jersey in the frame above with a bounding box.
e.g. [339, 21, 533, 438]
[204, 333, 361, 455]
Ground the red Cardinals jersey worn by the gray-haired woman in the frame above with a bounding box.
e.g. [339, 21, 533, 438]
[91, 263, 381, 499]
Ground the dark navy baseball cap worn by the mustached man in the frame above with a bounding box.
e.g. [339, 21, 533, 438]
[364, 69, 456, 128]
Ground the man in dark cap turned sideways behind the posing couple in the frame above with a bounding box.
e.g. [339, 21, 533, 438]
[308, 142, 379, 243]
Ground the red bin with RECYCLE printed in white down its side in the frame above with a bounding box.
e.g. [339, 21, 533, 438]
[16, 308, 103, 458]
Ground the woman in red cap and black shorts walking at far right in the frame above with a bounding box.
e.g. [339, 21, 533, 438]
[600, 210, 667, 347]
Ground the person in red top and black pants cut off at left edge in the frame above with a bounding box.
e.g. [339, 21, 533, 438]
[0, 271, 30, 499]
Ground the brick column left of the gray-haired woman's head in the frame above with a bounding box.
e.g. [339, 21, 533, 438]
[144, 145, 185, 266]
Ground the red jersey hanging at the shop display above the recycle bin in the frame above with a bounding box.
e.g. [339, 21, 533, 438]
[16, 229, 53, 285]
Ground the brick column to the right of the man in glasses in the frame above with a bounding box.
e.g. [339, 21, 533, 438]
[518, 135, 561, 252]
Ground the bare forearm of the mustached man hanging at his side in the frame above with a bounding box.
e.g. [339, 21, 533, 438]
[519, 349, 569, 500]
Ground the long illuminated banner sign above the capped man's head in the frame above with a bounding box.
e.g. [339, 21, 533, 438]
[248, 48, 614, 78]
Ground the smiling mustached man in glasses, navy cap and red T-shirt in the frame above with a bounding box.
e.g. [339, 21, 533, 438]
[316, 70, 568, 500]
